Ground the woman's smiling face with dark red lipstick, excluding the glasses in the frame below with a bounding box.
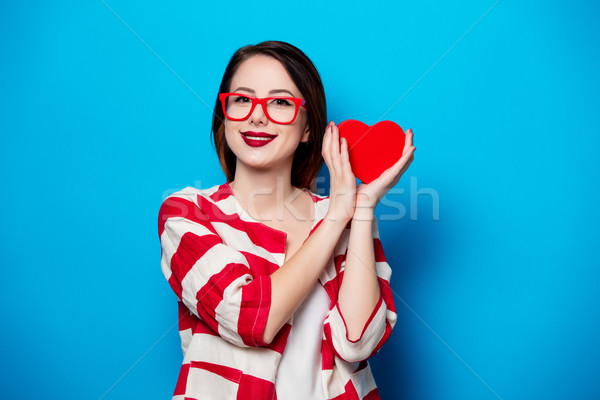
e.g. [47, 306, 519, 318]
[224, 55, 310, 175]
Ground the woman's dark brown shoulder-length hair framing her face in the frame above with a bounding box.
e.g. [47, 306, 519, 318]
[212, 41, 327, 188]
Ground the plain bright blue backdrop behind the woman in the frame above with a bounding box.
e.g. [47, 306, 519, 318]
[0, 0, 600, 400]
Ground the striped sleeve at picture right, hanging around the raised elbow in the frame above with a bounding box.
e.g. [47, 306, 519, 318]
[324, 220, 397, 362]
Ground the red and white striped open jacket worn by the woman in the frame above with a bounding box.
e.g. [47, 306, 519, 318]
[158, 183, 396, 400]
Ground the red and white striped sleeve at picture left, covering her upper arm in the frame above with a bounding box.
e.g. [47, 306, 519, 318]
[158, 195, 271, 347]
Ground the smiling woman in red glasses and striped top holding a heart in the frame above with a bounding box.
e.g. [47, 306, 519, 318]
[159, 41, 415, 400]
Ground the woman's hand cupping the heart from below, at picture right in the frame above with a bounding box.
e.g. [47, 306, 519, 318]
[356, 129, 416, 211]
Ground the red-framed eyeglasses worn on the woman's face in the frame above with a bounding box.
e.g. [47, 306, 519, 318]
[219, 93, 306, 125]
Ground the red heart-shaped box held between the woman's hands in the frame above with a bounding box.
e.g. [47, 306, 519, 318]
[338, 119, 405, 183]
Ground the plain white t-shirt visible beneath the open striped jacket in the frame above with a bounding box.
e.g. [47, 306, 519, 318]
[275, 281, 330, 400]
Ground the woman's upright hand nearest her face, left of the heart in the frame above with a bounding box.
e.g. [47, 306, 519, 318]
[321, 121, 356, 225]
